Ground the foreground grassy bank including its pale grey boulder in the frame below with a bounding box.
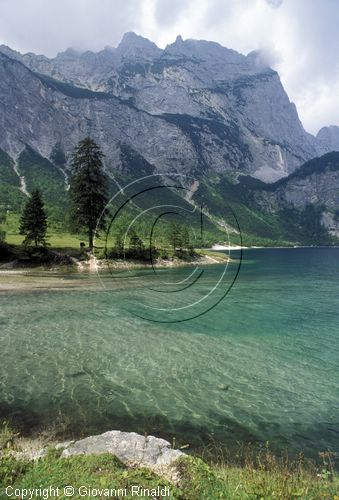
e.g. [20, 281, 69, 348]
[0, 426, 339, 500]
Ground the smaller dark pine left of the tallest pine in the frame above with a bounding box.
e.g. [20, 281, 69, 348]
[20, 189, 47, 247]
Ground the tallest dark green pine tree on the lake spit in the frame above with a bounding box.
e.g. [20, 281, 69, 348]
[70, 137, 108, 250]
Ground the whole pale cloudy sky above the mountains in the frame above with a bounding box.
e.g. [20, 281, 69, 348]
[0, 0, 339, 133]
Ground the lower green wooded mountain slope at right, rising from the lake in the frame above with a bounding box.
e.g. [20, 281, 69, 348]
[190, 152, 339, 245]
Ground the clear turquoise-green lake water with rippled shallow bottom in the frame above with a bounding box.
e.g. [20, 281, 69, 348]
[0, 249, 339, 457]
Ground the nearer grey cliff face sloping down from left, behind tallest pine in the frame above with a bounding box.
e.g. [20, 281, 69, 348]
[0, 54, 196, 177]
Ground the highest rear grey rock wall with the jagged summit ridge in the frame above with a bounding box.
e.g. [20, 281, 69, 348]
[0, 33, 334, 182]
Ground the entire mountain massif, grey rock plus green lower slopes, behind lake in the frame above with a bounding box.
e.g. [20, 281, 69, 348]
[0, 33, 339, 243]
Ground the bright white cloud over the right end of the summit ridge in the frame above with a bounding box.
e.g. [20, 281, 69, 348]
[149, 0, 339, 133]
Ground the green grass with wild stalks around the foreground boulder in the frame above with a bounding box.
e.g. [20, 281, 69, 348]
[0, 422, 339, 500]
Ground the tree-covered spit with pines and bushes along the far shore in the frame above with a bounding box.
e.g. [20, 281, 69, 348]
[0, 137, 231, 267]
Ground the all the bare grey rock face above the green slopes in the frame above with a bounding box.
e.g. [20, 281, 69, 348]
[0, 33, 330, 182]
